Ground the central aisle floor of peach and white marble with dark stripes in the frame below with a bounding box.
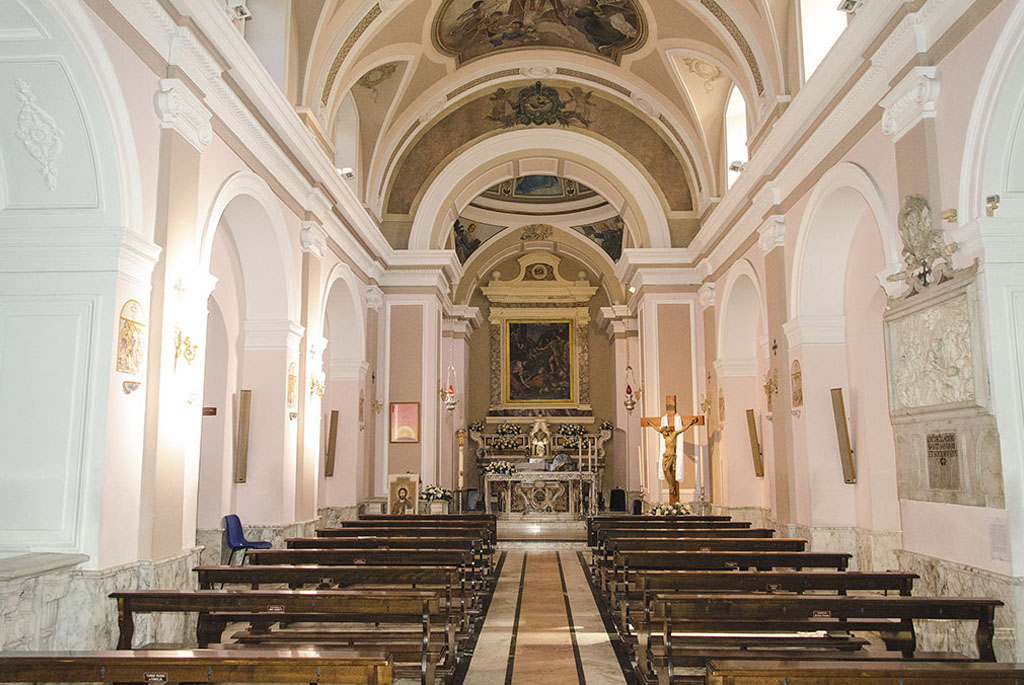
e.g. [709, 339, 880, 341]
[464, 550, 626, 685]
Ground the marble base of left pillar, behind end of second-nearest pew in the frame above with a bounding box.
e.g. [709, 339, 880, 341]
[52, 547, 200, 649]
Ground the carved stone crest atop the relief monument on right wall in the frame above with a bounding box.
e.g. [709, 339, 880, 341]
[889, 195, 956, 295]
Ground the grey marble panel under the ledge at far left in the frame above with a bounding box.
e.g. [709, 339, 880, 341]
[0, 554, 89, 651]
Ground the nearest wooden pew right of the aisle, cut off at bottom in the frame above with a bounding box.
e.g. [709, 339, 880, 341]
[707, 658, 1024, 685]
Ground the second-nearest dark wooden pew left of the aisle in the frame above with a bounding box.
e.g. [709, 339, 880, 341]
[110, 590, 448, 685]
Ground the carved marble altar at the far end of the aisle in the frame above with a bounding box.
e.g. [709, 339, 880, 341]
[483, 471, 599, 520]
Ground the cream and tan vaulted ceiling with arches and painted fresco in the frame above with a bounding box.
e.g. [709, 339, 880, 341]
[278, 0, 800, 247]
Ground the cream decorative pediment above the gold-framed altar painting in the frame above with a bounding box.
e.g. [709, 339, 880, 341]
[480, 252, 597, 306]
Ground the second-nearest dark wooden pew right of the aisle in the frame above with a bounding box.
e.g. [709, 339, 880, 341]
[638, 593, 1002, 685]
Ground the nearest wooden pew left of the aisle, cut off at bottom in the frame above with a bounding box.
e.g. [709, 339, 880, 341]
[0, 647, 393, 685]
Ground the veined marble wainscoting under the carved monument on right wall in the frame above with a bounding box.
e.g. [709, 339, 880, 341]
[897, 550, 1024, 661]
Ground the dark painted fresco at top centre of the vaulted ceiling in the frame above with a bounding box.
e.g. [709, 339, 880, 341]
[433, 0, 646, 63]
